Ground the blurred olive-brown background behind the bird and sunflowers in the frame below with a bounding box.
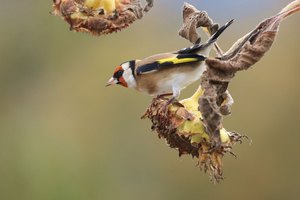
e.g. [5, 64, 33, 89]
[0, 0, 300, 200]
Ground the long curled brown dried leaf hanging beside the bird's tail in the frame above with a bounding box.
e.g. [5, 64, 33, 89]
[199, 0, 300, 145]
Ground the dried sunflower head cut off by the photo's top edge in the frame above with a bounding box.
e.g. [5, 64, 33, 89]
[52, 0, 153, 35]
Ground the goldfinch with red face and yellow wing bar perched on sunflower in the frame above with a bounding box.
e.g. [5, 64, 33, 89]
[106, 20, 233, 101]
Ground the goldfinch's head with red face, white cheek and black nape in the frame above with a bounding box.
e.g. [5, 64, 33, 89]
[106, 60, 136, 88]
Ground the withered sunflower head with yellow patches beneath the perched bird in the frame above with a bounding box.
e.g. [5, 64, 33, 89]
[143, 88, 245, 182]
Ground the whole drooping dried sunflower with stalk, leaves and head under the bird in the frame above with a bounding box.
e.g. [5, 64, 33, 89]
[144, 0, 300, 182]
